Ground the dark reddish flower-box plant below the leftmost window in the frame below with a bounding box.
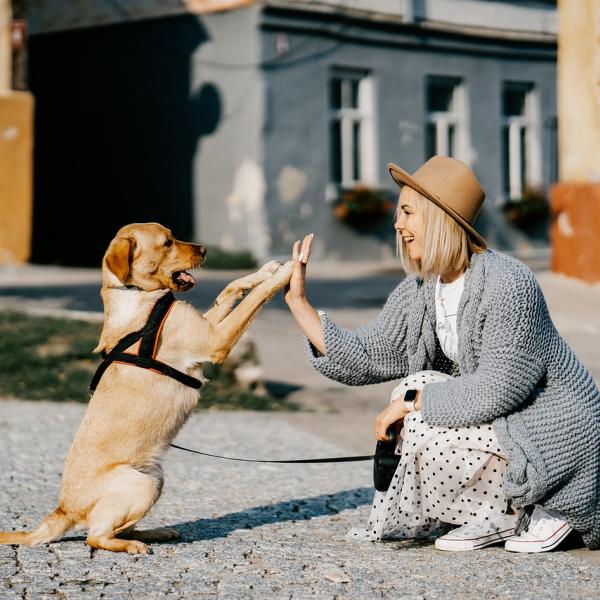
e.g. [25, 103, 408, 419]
[333, 185, 394, 227]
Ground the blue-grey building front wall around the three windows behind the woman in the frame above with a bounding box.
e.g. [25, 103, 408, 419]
[263, 11, 556, 259]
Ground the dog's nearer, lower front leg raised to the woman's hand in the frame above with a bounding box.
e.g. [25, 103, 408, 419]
[210, 260, 294, 363]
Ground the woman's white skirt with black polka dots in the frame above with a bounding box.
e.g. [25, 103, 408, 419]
[348, 371, 516, 541]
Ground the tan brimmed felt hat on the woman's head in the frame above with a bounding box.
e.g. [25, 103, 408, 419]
[388, 156, 487, 248]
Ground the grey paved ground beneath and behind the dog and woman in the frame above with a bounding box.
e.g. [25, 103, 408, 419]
[0, 257, 600, 599]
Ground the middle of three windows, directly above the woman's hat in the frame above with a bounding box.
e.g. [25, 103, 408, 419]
[425, 77, 465, 160]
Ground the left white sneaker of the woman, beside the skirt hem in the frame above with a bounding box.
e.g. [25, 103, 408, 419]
[435, 515, 517, 552]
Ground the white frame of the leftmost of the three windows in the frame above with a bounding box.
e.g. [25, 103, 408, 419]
[329, 69, 377, 187]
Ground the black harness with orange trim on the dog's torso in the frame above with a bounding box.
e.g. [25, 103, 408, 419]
[89, 292, 202, 394]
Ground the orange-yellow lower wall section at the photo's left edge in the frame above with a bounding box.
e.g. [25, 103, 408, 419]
[0, 92, 33, 264]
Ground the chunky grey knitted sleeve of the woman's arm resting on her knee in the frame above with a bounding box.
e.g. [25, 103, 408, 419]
[421, 266, 551, 427]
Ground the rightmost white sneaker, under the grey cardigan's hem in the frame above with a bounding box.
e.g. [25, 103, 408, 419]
[504, 505, 573, 552]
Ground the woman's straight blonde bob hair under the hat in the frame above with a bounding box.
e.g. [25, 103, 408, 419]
[396, 186, 484, 279]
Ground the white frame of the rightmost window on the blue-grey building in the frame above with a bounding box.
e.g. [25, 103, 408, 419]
[502, 81, 542, 200]
